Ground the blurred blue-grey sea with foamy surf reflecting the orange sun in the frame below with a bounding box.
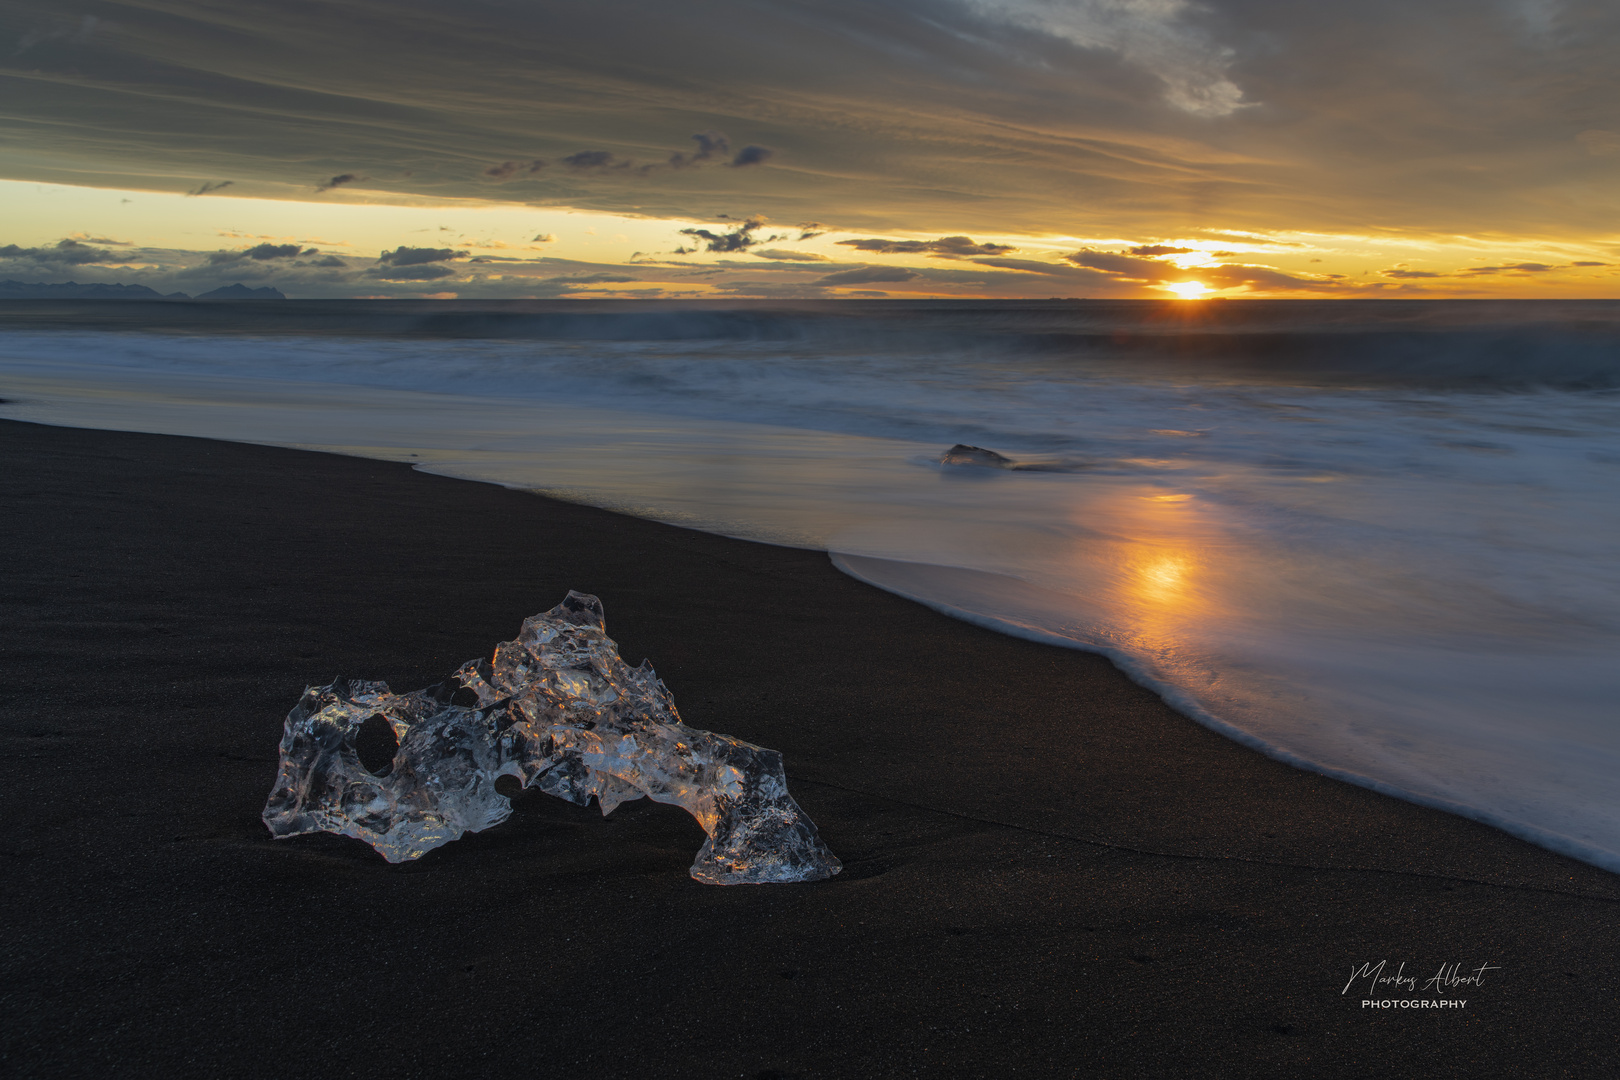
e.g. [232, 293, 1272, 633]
[9, 301, 1620, 871]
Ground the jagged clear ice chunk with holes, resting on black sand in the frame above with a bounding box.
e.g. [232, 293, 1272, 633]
[264, 593, 842, 884]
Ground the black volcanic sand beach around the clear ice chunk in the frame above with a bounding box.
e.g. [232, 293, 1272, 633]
[0, 423, 1620, 1078]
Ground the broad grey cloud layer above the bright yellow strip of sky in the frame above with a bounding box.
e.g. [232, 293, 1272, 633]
[0, 0, 1620, 238]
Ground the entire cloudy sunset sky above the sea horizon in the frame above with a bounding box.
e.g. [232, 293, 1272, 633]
[0, 0, 1620, 298]
